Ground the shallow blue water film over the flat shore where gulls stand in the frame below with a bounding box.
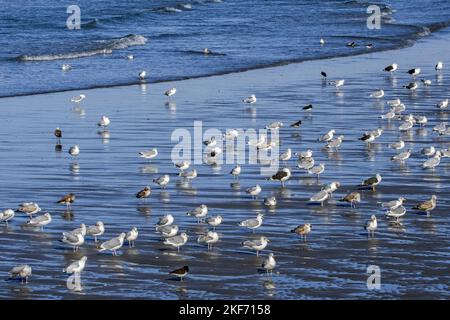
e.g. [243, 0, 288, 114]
[0, 30, 450, 299]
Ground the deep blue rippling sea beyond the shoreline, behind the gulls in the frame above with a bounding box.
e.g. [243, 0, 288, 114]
[0, 0, 450, 96]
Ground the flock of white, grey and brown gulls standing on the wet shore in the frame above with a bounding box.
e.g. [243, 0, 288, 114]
[0, 48, 450, 283]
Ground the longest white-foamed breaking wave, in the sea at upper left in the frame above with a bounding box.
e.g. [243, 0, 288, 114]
[15, 34, 148, 61]
